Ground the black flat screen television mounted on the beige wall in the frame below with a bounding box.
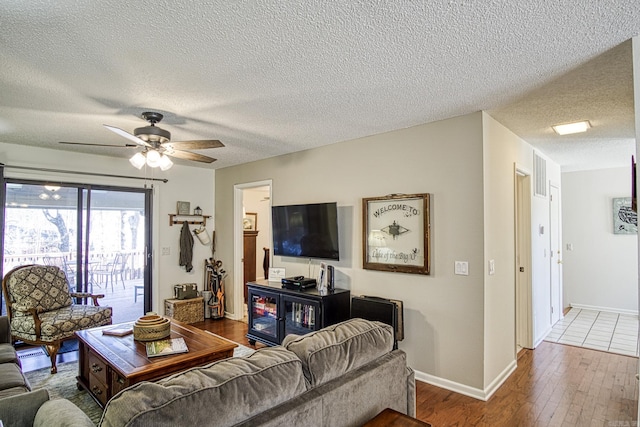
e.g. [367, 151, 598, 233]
[271, 202, 340, 260]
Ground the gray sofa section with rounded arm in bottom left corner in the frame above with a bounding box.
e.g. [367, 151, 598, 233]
[0, 316, 95, 427]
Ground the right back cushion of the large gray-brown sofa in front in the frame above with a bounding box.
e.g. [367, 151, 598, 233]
[282, 319, 393, 387]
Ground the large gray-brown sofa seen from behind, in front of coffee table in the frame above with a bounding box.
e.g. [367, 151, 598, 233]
[100, 319, 415, 427]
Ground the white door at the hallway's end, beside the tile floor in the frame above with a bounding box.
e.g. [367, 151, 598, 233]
[549, 185, 562, 325]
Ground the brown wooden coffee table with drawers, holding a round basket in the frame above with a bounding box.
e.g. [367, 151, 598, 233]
[76, 319, 238, 407]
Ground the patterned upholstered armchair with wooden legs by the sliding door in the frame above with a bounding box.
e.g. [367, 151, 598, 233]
[2, 265, 111, 374]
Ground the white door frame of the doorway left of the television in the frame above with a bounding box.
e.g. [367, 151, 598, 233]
[230, 179, 273, 320]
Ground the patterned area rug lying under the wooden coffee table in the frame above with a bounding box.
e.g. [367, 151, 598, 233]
[24, 344, 255, 425]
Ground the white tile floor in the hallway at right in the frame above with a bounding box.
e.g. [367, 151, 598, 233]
[545, 308, 638, 357]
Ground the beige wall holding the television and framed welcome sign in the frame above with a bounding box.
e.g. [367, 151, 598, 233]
[216, 113, 484, 389]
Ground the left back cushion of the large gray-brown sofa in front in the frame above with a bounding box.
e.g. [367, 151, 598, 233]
[100, 347, 306, 427]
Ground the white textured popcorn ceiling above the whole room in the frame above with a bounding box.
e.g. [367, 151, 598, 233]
[0, 0, 640, 173]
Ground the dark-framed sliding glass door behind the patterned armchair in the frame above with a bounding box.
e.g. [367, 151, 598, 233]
[2, 179, 151, 323]
